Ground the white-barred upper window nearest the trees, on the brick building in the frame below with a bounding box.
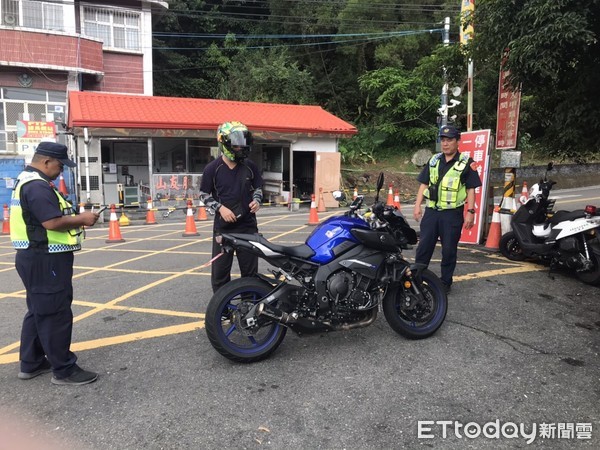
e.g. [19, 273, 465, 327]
[83, 6, 141, 51]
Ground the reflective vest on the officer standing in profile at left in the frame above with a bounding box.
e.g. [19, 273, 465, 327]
[10, 171, 83, 253]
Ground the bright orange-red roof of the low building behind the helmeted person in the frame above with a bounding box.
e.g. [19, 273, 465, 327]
[68, 91, 357, 135]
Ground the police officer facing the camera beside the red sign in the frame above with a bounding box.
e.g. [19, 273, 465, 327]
[413, 125, 481, 293]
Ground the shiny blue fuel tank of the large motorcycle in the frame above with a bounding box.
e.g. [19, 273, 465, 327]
[306, 217, 369, 264]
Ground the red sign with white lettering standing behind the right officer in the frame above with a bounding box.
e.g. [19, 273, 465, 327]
[458, 130, 490, 244]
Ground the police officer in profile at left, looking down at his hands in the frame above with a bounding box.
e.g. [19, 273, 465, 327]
[10, 142, 99, 385]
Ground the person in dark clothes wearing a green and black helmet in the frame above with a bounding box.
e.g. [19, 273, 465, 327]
[200, 121, 263, 292]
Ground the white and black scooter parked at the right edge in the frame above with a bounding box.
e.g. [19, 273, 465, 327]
[500, 163, 600, 285]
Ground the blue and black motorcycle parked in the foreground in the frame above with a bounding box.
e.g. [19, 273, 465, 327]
[205, 174, 448, 362]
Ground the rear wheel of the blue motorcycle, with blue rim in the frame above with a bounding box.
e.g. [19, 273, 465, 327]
[205, 277, 287, 363]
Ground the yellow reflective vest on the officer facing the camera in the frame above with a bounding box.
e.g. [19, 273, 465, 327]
[423, 153, 469, 209]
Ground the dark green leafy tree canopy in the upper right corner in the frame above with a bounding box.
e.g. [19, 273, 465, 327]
[473, 0, 600, 159]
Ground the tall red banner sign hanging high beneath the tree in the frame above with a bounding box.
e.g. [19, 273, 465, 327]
[496, 56, 521, 149]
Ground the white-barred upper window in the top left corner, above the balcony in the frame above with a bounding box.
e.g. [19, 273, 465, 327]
[0, 0, 65, 31]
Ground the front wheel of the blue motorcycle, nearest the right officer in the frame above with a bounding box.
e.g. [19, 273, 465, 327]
[383, 269, 448, 339]
